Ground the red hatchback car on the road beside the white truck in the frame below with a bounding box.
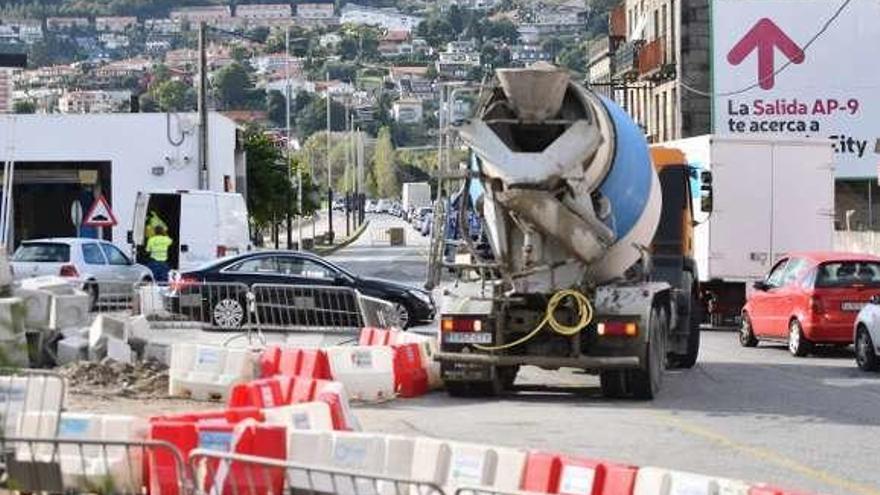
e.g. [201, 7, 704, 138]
[739, 252, 880, 356]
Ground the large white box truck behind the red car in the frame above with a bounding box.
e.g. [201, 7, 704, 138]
[663, 135, 834, 326]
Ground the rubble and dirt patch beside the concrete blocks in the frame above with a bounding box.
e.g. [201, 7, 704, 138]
[57, 359, 168, 399]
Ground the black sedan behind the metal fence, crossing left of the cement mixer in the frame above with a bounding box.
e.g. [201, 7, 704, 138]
[169, 251, 435, 328]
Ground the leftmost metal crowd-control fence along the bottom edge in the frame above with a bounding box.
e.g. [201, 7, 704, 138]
[0, 437, 192, 495]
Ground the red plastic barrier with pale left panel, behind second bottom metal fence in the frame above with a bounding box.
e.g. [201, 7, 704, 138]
[198, 420, 287, 495]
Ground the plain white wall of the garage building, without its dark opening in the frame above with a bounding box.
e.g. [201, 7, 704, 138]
[0, 113, 244, 246]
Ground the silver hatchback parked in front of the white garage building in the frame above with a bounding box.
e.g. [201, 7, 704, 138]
[12, 237, 153, 306]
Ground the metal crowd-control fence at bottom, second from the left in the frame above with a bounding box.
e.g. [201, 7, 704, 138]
[189, 450, 444, 495]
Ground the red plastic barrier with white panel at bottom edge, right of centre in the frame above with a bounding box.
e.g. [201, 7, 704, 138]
[522, 452, 638, 495]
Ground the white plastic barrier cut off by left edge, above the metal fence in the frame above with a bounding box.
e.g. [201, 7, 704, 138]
[0, 375, 65, 437]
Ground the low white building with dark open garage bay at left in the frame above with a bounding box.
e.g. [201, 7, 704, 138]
[0, 113, 246, 248]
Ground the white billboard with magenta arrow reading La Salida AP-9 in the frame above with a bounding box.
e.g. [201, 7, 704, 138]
[712, 0, 880, 178]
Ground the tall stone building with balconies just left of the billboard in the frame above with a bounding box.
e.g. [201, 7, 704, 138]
[588, 0, 712, 142]
